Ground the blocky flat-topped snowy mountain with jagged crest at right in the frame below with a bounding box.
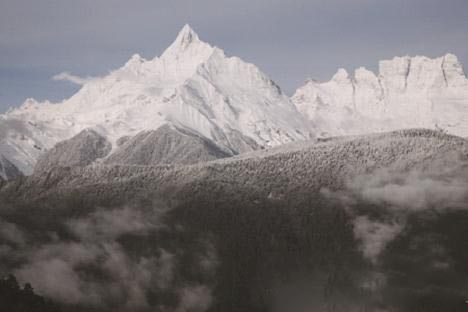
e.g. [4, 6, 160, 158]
[292, 54, 468, 137]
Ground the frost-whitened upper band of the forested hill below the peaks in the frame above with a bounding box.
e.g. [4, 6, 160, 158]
[1, 129, 468, 201]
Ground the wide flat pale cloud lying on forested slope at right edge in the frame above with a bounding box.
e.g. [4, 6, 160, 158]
[348, 154, 468, 212]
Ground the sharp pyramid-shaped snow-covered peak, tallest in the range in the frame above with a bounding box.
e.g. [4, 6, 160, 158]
[0, 26, 311, 174]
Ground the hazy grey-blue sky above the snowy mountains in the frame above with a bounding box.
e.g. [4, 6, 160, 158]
[0, 0, 468, 112]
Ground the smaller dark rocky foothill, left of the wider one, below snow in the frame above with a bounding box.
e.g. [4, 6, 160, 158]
[35, 129, 112, 172]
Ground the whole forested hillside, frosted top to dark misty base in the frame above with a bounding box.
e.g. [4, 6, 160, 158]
[0, 129, 468, 312]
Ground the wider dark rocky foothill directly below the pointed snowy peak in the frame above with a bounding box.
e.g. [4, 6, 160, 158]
[105, 125, 232, 166]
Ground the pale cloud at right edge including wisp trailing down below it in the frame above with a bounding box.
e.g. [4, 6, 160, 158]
[323, 152, 468, 265]
